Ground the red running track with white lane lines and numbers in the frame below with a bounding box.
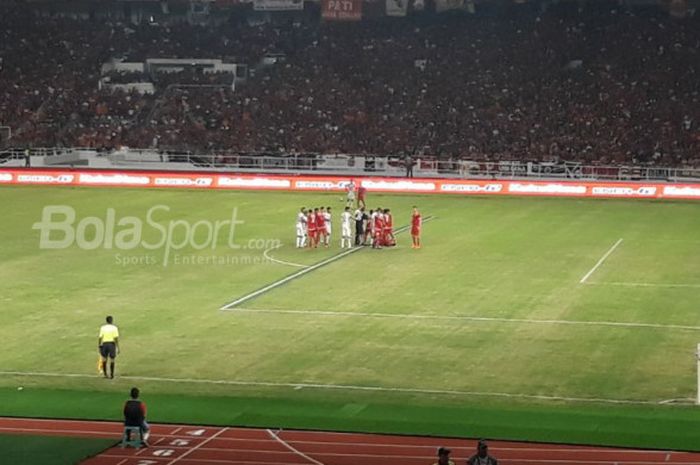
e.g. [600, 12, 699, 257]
[0, 418, 700, 465]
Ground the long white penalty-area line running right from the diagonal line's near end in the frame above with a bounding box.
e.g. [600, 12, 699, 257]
[231, 308, 700, 331]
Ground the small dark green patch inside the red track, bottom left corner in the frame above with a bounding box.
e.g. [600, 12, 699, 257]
[0, 434, 115, 465]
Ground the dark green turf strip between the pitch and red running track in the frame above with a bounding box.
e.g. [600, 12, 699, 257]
[0, 389, 700, 451]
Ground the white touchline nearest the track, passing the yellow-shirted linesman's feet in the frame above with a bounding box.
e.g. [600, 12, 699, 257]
[0, 371, 664, 405]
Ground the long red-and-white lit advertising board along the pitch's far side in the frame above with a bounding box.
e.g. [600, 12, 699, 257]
[0, 169, 700, 200]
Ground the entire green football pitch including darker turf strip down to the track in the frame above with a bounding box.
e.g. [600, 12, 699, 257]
[0, 188, 700, 449]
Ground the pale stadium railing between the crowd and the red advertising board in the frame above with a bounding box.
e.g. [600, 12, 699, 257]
[0, 147, 700, 182]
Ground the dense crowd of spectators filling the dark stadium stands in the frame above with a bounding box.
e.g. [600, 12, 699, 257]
[0, 3, 700, 167]
